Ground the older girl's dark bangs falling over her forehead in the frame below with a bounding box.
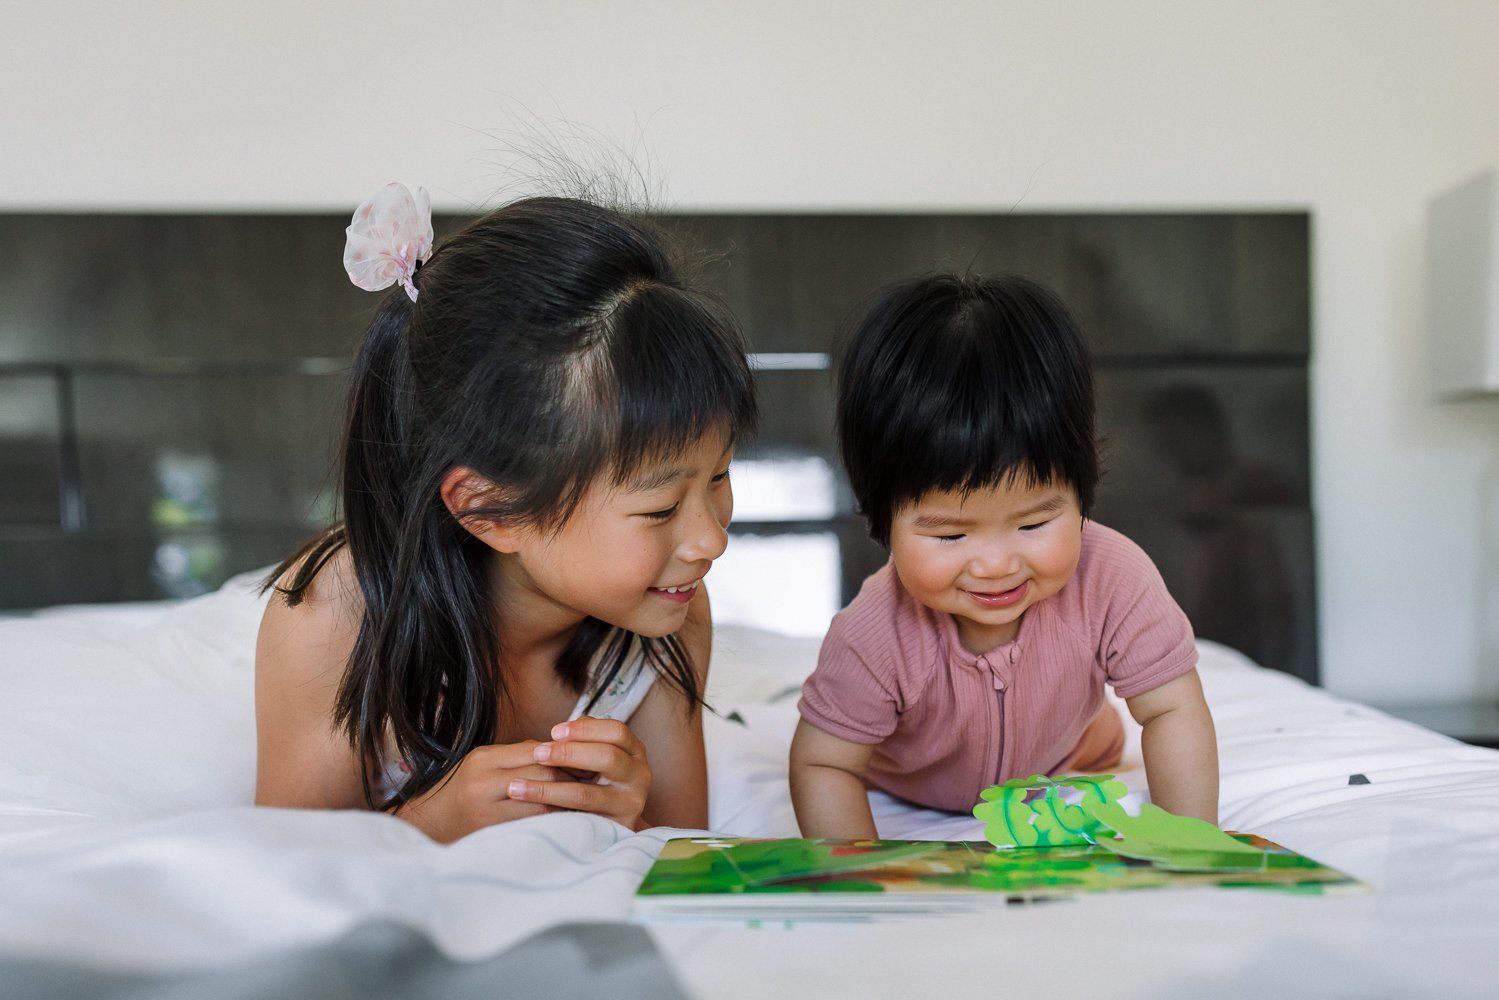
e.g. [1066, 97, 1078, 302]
[606, 285, 757, 483]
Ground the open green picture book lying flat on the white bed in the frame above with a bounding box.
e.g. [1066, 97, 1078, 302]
[633, 834, 1363, 922]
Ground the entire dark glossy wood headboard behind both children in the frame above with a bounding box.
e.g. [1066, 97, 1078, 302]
[0, 213, 1318, 681]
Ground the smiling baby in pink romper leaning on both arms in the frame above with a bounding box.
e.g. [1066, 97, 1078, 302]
[791, 276, 1217, 838]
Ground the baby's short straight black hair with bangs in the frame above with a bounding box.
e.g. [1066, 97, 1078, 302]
[838, 274, 1099, 546]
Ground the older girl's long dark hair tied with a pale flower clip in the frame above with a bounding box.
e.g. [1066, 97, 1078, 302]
[271, 198, 755, 808]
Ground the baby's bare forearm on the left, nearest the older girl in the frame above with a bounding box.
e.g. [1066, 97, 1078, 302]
[790, 718, 878, 840]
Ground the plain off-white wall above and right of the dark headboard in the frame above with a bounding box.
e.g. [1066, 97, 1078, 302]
[0, 0, 1499, 699]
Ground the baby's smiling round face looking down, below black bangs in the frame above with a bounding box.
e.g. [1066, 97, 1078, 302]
[890, 481, 1082, 652]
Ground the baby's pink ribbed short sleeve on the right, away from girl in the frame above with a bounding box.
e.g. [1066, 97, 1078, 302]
[1094, 531, 1198, 699]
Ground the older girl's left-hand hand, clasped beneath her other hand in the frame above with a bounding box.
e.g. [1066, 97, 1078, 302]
[394, 739, 558, 844]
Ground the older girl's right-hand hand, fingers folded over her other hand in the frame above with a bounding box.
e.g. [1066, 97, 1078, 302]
[508, 717, 651, 831]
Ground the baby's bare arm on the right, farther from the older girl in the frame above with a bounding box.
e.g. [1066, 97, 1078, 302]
[1126, 670, 1219, 823]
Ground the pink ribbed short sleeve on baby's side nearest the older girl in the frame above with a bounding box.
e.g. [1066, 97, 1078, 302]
[796, 618, 901, 744]
